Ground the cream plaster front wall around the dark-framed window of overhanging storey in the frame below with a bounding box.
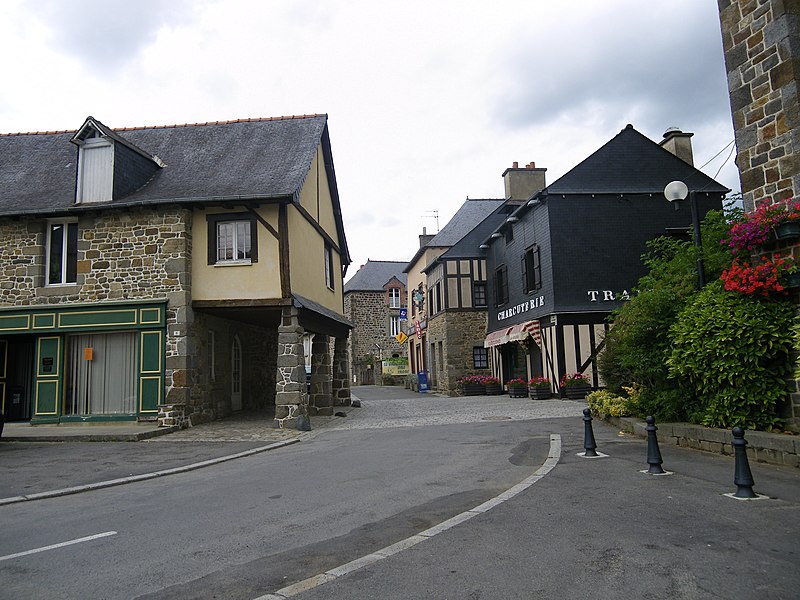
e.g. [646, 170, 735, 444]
[192, 206, 281, 300]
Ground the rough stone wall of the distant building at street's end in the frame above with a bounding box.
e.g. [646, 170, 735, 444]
[344, 290, 406, 385]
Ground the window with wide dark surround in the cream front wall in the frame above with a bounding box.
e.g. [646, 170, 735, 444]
[207, 213, 258, 265]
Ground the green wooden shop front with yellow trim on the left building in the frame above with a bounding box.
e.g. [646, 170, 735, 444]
[0, 301, 166, 425]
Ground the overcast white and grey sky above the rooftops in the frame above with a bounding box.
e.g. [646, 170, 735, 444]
[0, 0, 739, 277]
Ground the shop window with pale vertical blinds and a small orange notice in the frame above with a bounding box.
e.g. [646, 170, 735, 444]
[64, 332, 139, 415]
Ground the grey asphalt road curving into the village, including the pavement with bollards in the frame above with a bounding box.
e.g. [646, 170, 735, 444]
[0, 390, 800, 600]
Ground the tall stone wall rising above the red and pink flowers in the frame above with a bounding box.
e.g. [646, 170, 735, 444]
[718, 0, 800, 210]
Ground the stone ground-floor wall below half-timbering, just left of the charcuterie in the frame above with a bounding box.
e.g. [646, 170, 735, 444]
[427, 310, 492, 396]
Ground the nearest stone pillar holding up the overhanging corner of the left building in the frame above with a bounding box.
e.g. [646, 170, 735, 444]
[275, 306, 309, 429]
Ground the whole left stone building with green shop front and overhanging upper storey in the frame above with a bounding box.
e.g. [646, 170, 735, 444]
[0, 115, 350, 425]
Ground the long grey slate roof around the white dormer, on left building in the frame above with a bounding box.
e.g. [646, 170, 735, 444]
[0, 115, 327, 215]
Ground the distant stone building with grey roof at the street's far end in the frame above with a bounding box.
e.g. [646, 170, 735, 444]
[344, 260, 407, 385]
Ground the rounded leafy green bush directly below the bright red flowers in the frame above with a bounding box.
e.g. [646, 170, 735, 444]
[668, 281, 794, 430]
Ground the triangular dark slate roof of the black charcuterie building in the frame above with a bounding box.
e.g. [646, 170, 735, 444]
[545, 125, 729, 195]
